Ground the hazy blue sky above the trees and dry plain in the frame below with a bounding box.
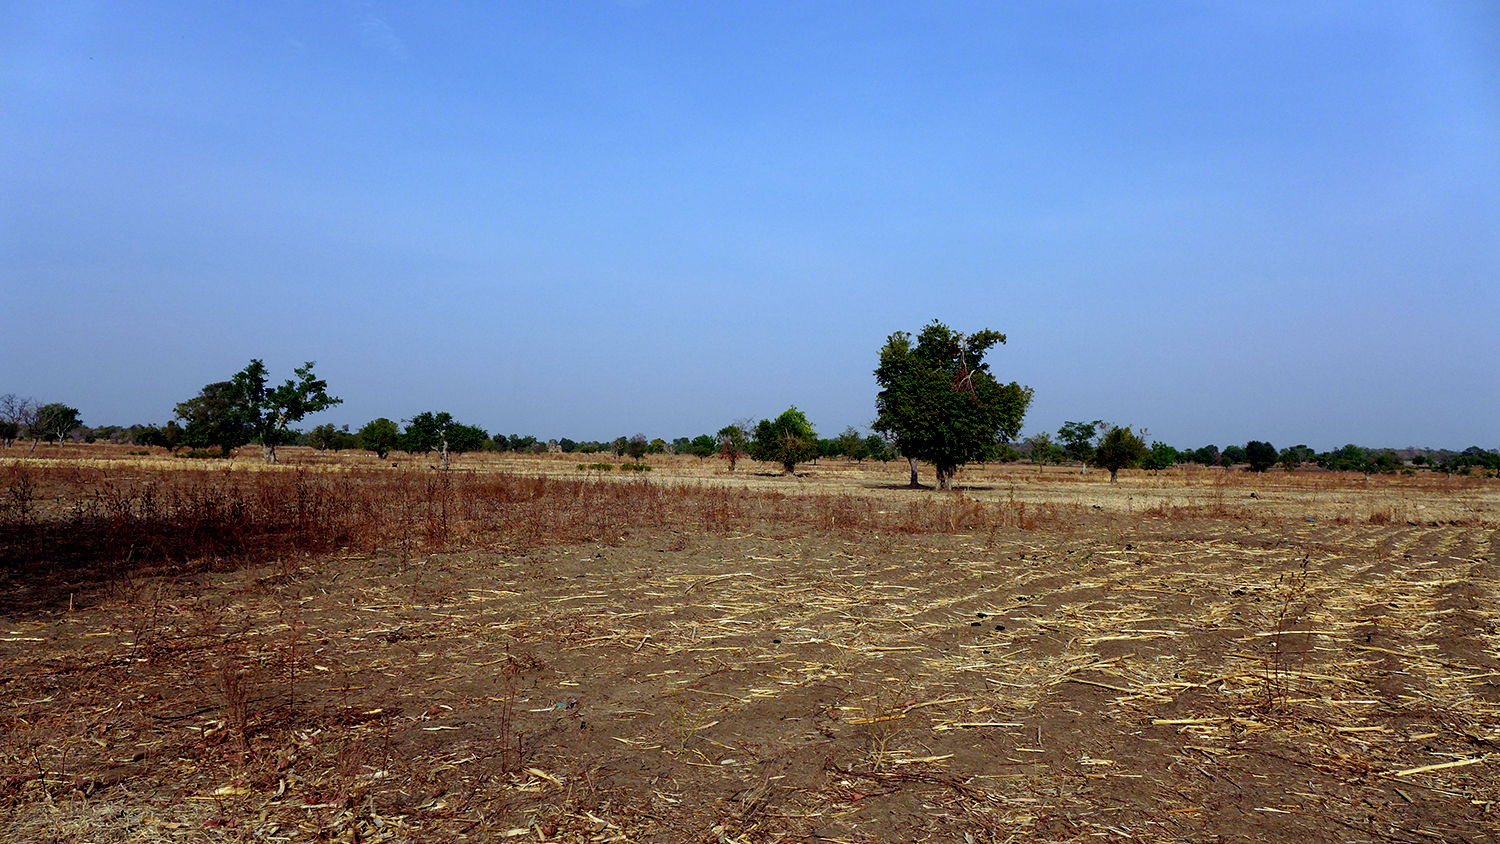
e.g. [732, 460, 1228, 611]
[0, 0, 1500, 448]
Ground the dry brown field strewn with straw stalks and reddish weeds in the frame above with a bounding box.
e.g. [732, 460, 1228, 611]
[0, 447, 1500, 844]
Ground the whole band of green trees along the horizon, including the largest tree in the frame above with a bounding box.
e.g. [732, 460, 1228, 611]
[0, 338, 1500, 487]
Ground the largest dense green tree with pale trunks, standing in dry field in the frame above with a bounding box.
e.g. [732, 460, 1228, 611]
[875, 321, 1032, 487]
